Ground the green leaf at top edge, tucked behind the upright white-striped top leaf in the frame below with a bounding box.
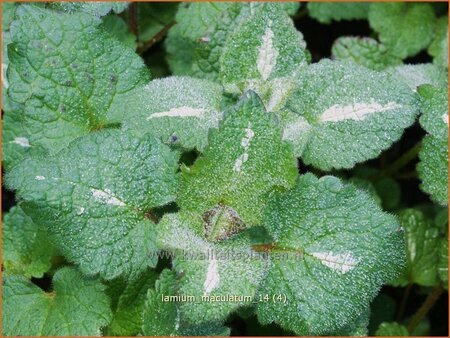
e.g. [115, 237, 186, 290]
[165, 2, 299, 81]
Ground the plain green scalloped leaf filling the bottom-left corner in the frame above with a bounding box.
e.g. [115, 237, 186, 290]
[2, 268, 111, 336]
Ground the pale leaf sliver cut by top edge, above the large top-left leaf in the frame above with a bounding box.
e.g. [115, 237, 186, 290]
[52, 1, 128, 17]
